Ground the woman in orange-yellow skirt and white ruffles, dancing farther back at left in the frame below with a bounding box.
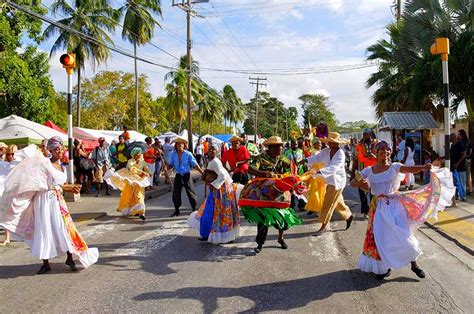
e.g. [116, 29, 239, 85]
[104, 147, 150, 220]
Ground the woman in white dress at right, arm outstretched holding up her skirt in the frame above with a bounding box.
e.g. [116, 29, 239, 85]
[351, 141, 455, 279]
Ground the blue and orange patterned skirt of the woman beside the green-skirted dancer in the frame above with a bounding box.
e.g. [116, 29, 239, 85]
[188, 184, 240, 244]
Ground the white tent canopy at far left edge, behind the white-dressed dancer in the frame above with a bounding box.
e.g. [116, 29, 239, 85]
[0, 115, 68, 145]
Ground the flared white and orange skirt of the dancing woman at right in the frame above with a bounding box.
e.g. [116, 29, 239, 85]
[357, 168, 455, 274]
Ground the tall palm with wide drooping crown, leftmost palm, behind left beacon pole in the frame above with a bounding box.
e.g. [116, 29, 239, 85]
[43, 0, 117, 126]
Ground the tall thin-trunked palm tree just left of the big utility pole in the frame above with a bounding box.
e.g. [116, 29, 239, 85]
[119, 0, 161, 130]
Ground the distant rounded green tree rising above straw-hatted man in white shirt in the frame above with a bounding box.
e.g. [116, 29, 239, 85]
[298, 94, 338, 130]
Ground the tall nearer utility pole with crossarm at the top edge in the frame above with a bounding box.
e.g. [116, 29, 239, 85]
[173, 0, 209, 153]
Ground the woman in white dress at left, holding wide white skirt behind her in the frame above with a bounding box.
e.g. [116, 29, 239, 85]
[0, 137, 99, 274]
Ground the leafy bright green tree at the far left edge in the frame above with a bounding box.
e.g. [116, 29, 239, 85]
[0, 1, 57, 123]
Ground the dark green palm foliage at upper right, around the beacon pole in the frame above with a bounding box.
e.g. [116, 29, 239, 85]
[367, 0, 474, 121]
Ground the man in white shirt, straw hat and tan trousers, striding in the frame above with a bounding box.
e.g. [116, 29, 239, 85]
[307, 132, 354, 236]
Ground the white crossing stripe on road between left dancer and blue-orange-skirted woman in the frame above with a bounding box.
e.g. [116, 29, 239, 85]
[111, 221, 189, 257]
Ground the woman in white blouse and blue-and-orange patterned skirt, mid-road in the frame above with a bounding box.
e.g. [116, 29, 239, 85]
[188, 146, 240, 244]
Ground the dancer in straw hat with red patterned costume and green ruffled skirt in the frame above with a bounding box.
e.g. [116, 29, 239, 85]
[239, 136, 302, 253]
